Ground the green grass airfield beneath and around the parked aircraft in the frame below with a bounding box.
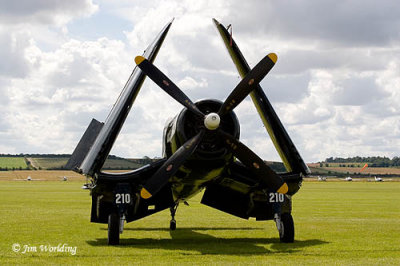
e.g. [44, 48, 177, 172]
[0, 181, 400, 265]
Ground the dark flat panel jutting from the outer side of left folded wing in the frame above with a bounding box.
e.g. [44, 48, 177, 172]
[65, 118, 104, 170]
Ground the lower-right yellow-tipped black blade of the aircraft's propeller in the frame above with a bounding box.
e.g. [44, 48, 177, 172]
[219, 130, 289, 194]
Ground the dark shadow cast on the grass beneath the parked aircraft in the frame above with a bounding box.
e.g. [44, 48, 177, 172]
[87, 227, 328, 256]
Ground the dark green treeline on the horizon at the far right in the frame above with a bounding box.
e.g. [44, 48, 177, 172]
[325, 156, 400, 167]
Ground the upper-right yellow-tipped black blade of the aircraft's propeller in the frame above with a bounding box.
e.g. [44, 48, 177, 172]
[218, 53, 278, 116]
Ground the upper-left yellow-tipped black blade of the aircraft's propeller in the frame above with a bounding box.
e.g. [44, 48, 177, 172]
[135, 56, 204, 116]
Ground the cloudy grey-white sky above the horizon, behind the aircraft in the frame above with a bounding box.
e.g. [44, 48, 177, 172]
[0, 0, 400, 162]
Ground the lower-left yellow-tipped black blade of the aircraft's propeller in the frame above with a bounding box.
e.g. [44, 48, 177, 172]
[140, 130, 204, 199]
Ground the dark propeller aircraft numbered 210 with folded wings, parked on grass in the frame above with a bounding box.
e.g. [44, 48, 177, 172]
[67, 19, 310, 245]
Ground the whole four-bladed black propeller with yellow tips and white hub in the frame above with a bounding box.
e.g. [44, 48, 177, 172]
[135, 53, 288, 199]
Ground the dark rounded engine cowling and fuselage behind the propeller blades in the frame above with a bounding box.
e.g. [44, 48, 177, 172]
[163, 100, 240, 200]
